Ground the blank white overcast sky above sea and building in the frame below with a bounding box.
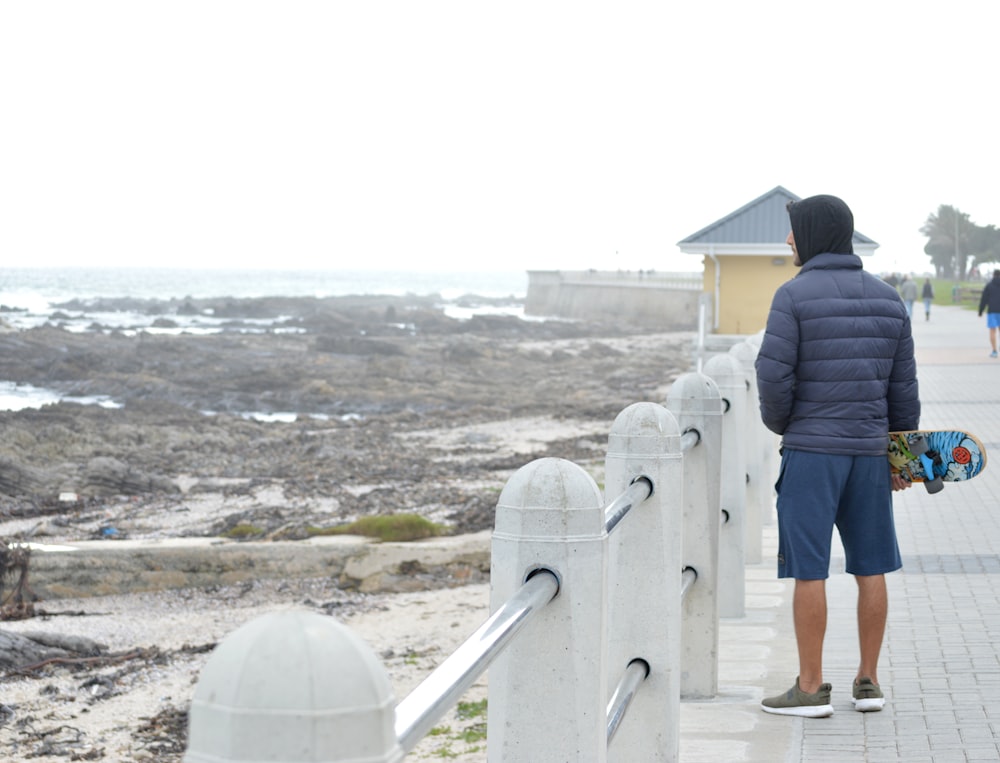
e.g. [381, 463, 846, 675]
[0, 0, 1000, 278]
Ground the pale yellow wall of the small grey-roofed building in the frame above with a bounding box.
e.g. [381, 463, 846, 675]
[704, 254, 799, 334]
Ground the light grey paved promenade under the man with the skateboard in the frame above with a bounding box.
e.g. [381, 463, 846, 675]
[681, 305, 1000, 763]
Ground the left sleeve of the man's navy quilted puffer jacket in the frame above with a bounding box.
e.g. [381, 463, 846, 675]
[756, 288, 799, 434]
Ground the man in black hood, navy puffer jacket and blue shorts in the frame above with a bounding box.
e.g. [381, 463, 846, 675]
[756, 196, 920, 718]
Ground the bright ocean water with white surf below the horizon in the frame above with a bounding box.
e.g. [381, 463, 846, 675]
[0, 267, 528, 418]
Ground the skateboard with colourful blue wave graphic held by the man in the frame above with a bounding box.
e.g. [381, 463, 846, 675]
[889, 429, 986, 493]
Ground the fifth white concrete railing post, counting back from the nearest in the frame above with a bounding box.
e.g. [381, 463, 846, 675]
[705, 354, 747, 617]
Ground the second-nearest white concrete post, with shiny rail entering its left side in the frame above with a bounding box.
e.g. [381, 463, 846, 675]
[487, 458, 608, 763]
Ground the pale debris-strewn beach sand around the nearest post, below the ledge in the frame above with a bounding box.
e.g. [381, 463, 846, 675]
[0, 580, 489, 763]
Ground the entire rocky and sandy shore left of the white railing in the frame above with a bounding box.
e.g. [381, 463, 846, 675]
[0, 298, 693, 763]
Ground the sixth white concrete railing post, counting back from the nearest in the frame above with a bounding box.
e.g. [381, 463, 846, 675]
[729, 341, 771, 564]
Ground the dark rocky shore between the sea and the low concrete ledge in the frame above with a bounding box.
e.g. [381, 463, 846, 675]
[0, 297, 691, 541]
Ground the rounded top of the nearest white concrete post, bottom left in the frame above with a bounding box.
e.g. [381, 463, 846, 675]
[184, 610, 403, 763]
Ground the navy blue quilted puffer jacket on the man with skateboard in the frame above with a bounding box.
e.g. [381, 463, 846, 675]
[756, 252, 920, 456]
